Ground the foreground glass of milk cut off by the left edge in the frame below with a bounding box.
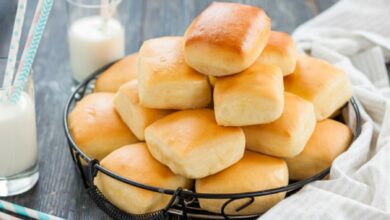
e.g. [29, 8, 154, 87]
[0, 59, 39, 197]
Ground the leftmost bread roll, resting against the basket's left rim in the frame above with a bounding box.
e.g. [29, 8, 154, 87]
[68, 93, 138, 160]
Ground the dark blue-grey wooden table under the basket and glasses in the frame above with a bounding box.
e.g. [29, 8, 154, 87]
[0, 0, 337, 219]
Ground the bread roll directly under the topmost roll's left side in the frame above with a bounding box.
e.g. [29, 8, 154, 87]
[139, 37, 211, 109]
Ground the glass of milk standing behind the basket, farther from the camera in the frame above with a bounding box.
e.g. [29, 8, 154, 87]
[67, 0, 126, 82]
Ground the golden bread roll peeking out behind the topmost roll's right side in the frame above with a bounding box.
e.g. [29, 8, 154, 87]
[256, 31, 298, 76]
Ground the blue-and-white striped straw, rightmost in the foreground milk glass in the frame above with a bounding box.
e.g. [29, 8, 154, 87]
[11, 0, 53, 103]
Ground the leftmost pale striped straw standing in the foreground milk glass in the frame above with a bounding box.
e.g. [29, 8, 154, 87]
[3, 0, 27, 88]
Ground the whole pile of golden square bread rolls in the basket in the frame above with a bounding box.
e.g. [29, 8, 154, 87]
[69, 3, 352, 215]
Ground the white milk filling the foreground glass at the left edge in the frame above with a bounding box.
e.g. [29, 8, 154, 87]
[0, 91, 37, 177]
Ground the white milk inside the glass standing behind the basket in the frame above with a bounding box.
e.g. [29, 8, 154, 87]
[68, 16, 125, 81]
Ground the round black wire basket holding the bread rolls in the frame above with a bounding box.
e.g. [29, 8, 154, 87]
[63, 62, 361, 220]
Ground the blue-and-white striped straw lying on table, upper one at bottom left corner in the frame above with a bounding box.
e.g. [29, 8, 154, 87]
[0, 200, 64, 220]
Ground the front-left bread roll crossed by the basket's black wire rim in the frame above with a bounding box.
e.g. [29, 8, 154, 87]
[95, 143, 192, 214]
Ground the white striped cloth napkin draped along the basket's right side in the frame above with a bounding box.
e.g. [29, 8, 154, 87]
[261, 0, 390, 220]
